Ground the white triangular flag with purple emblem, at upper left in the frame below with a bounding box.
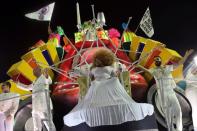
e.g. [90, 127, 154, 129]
[25, 2, 55, 21]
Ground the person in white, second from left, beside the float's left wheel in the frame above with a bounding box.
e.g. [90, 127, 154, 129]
[32, 67, 56, 131]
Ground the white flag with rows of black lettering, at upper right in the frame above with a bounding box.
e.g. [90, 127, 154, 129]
[140, 7, 154, 37]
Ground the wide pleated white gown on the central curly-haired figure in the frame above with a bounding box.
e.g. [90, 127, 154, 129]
[64, 66, 154, 127]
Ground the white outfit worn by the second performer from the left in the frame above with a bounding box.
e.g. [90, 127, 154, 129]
[17, 74, 56, 131]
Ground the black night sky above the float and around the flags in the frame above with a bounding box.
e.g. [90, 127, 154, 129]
[0, 0, 197, 82]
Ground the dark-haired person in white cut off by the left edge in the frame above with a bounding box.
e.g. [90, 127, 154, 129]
[0, 82, 20, 131]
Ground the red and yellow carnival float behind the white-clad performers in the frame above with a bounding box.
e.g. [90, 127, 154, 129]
[0, 2, 192, 131]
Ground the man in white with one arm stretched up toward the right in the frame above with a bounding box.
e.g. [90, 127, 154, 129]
[141, 50, 193, 131]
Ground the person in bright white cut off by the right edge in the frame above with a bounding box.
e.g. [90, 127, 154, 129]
[185, 67, 197, 131]
